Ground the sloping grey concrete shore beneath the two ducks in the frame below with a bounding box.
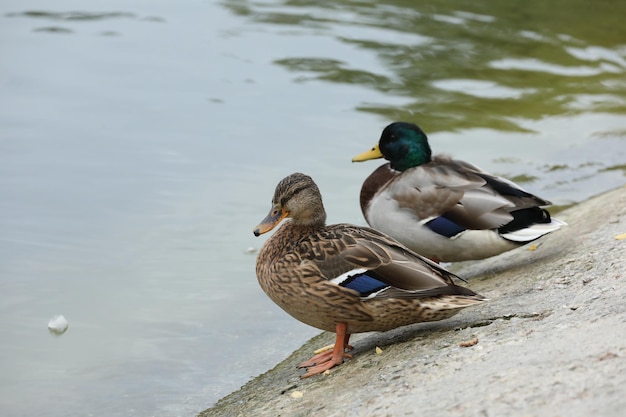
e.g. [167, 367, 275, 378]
[199, 186, 626, 417]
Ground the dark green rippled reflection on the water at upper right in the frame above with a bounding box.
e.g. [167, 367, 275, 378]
[224, 0, 626, 132]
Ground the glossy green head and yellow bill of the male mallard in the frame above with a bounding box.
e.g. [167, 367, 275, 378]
[352, 122, 431, 171]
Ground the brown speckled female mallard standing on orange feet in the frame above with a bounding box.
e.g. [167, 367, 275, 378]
[254, 173, 485, 378]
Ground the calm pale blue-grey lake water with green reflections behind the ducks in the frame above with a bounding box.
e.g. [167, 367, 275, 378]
[0, 0, 626, 417]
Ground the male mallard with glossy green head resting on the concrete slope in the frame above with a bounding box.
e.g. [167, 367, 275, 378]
[352, 122, 565, 262]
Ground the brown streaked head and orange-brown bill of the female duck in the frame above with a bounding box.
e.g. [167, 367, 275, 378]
[253, 172, 326, 236]
